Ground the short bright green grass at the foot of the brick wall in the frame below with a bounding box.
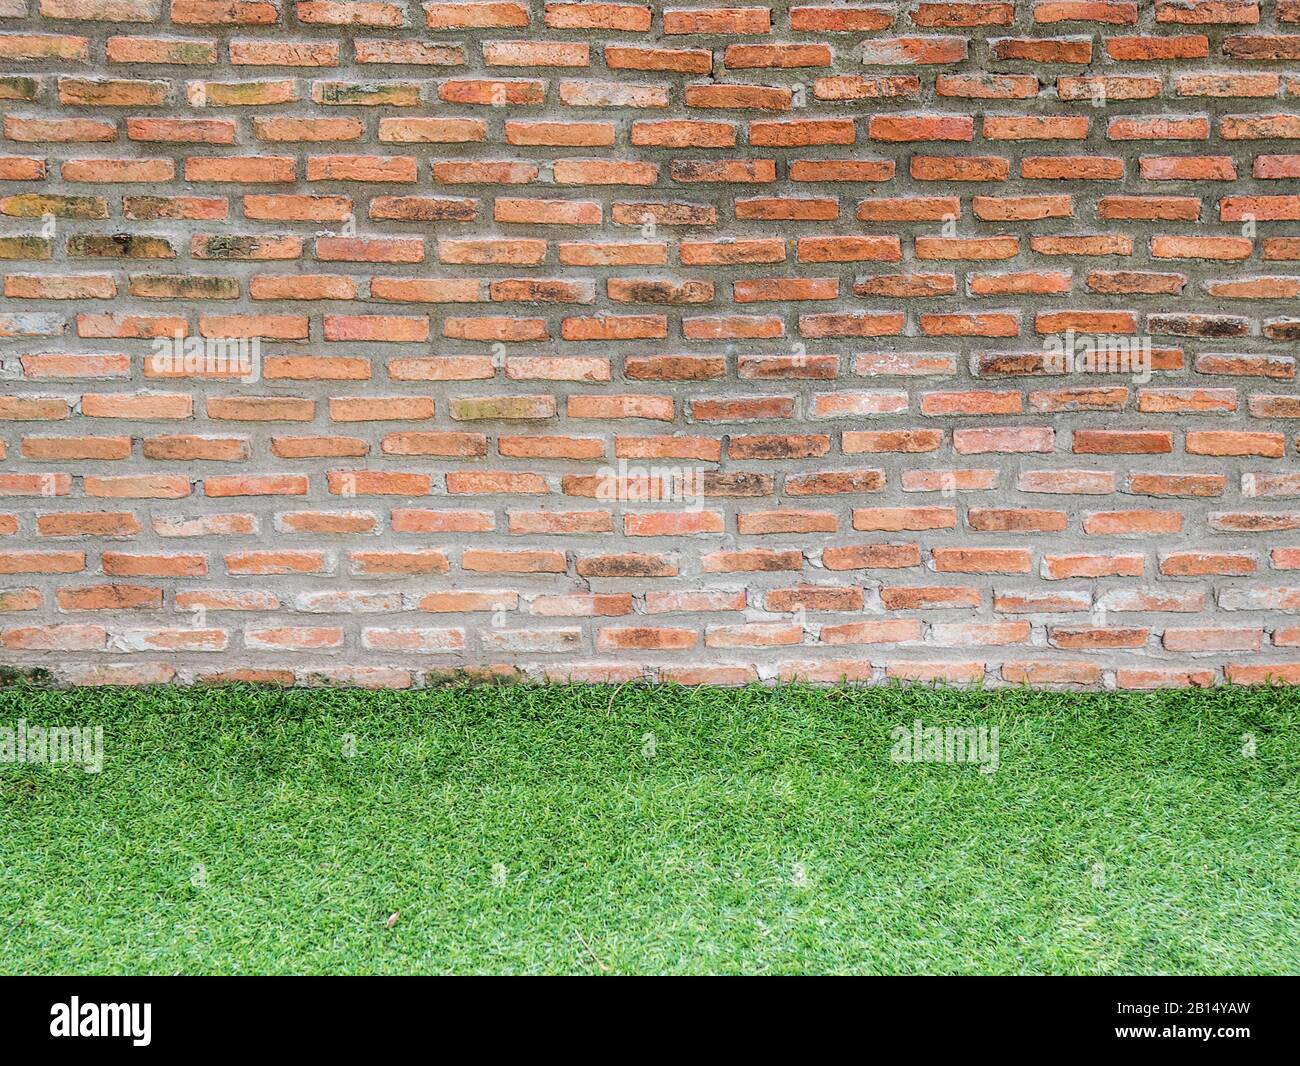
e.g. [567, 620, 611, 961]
[0, 686, 1300, 974]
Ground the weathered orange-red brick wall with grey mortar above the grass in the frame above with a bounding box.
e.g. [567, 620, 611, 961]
[0, 0, 1300, 688]
